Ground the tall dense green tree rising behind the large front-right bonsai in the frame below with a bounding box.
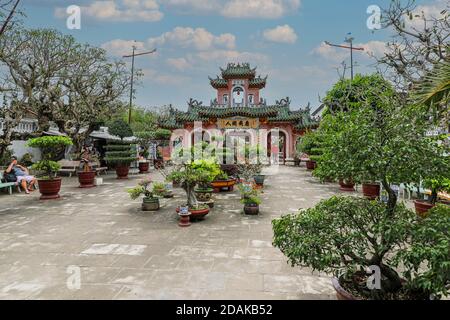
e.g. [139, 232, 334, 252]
[318, 75, 450, 211]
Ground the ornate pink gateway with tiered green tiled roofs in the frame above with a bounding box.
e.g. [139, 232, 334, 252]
[160, 63, 318, 161]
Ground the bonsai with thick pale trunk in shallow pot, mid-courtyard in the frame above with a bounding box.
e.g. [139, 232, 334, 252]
[168, 160, 217, 220]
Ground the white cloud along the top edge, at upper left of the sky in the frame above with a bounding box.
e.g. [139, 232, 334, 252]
[55, 0, 164, 22]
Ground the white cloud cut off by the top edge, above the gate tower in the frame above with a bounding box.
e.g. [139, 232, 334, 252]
[222, 0, 300, 19]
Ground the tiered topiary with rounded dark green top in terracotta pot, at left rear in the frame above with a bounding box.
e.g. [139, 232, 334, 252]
[105, 119, 136, 179]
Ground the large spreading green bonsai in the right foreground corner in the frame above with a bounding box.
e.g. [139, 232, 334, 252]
[272, 197, 450, 299]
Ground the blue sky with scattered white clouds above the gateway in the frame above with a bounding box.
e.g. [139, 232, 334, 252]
[22, 0, 446, 109]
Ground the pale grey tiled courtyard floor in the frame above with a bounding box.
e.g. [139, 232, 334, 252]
[0, 166, 352, 299]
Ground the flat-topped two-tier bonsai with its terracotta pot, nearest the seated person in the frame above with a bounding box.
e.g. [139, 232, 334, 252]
[27, 136, 73, 200]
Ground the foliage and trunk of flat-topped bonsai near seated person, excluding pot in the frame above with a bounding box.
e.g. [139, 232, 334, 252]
[27, 136, 73, 179]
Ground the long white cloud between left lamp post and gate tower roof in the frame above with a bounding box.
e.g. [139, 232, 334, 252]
[148, 27, 236, 50]
